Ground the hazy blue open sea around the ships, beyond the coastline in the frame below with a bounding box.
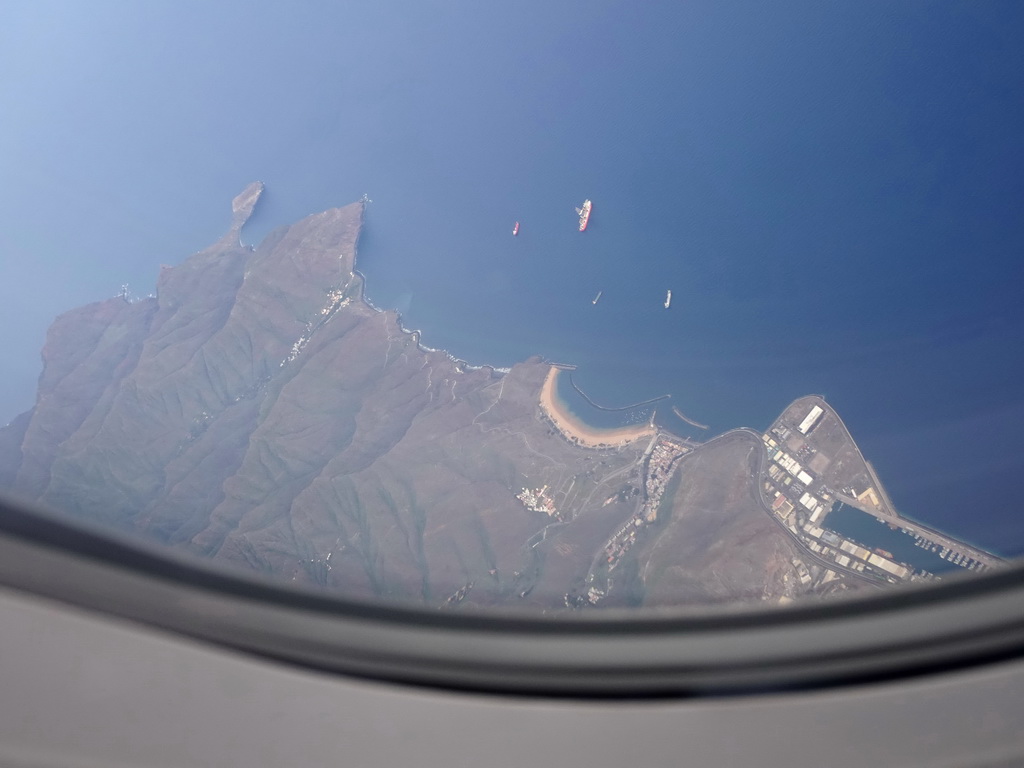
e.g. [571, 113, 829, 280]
[6, 0, 1024, 554]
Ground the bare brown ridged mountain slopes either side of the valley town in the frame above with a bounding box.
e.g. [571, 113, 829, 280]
[0, 183, 856, 610]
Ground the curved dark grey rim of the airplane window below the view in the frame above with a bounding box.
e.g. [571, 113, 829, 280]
[0, 501, 1024, 698]
